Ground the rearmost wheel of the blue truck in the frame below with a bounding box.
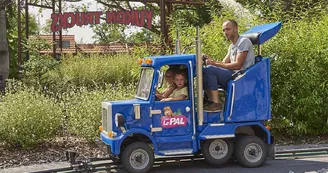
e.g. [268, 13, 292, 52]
[235, 136, 268, 168]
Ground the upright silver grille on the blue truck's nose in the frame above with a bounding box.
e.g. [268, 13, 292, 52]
[102, 102, 112, 132]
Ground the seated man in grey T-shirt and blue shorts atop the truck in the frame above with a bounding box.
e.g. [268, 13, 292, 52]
[203, 20, 255, 112]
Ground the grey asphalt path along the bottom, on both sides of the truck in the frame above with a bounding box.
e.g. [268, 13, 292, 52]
[0, 155, 328, 173]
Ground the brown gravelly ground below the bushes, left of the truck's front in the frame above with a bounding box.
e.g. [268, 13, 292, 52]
[0, 137, 105, 169]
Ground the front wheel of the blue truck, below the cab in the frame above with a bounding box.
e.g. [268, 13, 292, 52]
[122, 142, 154, 173]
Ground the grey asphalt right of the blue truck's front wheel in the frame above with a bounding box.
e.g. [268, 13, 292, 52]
[152, 155, 328, 173]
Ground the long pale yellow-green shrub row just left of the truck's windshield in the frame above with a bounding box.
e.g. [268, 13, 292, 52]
[60, 54, 139, 86]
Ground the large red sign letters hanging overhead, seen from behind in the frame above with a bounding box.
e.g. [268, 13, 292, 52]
[51, 10, 153, 32]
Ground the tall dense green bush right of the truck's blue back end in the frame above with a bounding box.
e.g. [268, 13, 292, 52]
[263, 15, 328, 134]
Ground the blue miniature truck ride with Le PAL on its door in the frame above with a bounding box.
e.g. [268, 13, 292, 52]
[97, 22, 281, 173]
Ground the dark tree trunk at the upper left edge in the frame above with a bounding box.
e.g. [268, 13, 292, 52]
[0, 5, 9, 90]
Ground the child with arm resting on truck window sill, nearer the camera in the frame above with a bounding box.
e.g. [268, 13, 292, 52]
[161, 71, 188, 102]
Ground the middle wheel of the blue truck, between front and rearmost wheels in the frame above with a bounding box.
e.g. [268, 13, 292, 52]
[202, 139, 233, 166]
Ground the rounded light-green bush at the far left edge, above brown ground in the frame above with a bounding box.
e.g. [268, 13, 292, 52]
[0, 85, 62, 148]
